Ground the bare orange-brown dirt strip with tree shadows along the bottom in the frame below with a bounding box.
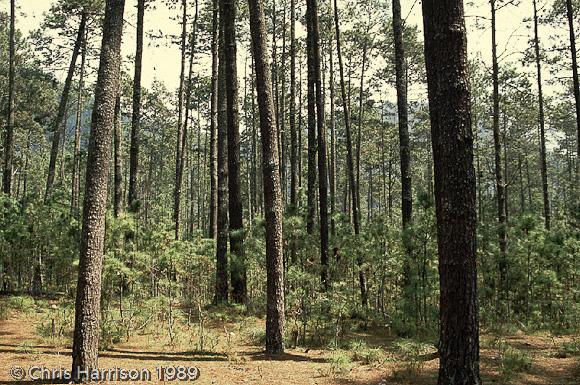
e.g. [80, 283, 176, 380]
[0, 312, 580, 385]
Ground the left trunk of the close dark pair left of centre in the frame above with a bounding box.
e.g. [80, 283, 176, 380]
[216, 20, 229, 303]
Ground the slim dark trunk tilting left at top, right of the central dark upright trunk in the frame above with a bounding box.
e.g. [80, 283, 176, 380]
[334, 0, 368, 307]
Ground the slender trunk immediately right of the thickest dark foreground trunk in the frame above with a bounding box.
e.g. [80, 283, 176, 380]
[490, 0, 507, 304]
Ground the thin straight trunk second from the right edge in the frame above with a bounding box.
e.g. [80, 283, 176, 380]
[534, 0, 551, 230]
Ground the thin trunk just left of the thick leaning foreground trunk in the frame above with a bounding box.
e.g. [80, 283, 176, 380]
[71, 34, 87, 212]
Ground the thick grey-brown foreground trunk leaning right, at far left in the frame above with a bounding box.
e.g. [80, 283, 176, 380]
[72, 0, 125, 380]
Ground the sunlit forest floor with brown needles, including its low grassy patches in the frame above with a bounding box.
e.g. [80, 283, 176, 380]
[0, 298, 580, 385]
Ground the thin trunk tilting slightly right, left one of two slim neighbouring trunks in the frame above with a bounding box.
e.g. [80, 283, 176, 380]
[173, 0, 188, 239]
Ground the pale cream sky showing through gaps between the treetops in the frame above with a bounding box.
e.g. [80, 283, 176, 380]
[0, 0, 567, 98]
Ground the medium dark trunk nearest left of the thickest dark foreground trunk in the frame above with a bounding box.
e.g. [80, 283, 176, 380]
[393, 0, 413, 229]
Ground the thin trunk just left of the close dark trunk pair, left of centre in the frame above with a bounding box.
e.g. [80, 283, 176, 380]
[209, 0, 219, 239]
